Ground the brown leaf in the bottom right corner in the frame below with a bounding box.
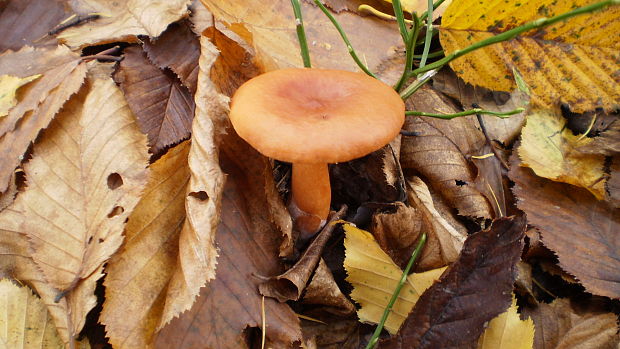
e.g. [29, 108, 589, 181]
[524, 299, 620, 349]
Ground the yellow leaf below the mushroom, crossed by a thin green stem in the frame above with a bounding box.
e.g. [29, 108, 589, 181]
[344, 224, 446, 334]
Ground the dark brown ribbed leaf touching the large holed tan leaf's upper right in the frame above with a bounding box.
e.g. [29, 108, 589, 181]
[114, 46, 195, 154]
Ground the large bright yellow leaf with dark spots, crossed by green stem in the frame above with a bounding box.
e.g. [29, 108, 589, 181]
[440, 0, 620, 112]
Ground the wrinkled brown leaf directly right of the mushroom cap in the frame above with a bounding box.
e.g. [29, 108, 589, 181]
[400, 87, 492, 218]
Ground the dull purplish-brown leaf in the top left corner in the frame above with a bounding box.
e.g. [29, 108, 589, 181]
[0, 0, 69, 52]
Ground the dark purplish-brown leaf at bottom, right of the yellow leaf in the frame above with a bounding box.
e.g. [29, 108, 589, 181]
[380, 216, 526, 348]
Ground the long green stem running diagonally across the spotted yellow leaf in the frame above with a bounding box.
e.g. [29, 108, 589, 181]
[410, 0, 620, 76]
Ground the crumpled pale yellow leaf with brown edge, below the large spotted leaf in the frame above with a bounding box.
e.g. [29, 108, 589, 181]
[519, 110, 605, 200]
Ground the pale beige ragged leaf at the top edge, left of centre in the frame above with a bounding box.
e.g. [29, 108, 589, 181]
[57, 0, 190, 48]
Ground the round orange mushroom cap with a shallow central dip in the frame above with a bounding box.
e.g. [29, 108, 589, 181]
[230, 68, 405, 163]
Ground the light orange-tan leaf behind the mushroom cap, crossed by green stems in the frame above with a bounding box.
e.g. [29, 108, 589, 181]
[201, 0, 402, 71]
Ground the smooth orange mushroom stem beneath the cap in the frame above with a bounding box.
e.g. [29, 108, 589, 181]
[289, 163, 331, 239]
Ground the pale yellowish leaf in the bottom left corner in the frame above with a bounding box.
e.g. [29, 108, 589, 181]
[0, 279, 63, 349]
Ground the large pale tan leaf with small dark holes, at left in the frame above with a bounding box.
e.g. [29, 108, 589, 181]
[15, 67, 147, 332]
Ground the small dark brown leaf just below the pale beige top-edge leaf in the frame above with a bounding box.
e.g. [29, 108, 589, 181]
[144, 21, 200, 94]
